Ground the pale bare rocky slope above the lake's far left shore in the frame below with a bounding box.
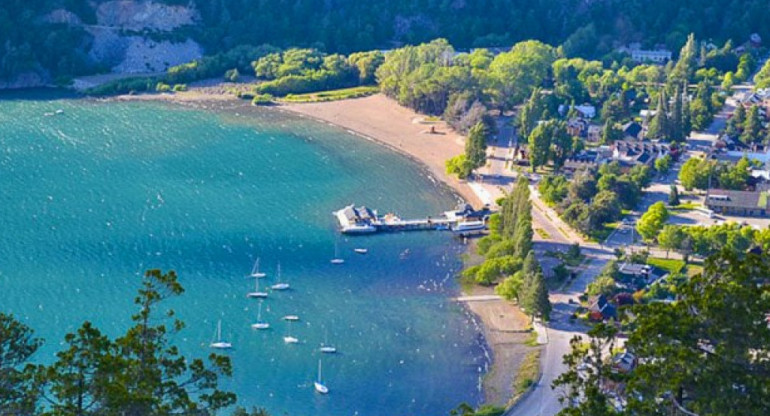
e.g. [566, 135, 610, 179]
[0, 0, 203, 88]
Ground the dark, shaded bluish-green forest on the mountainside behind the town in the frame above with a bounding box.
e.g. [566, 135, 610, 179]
[0, 0, 770, 83]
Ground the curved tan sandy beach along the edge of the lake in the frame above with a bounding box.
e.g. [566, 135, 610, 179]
[108, 90, 526, 406]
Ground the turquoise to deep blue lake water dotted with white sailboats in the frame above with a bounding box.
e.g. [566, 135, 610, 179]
[0, 93, 486, 415]
